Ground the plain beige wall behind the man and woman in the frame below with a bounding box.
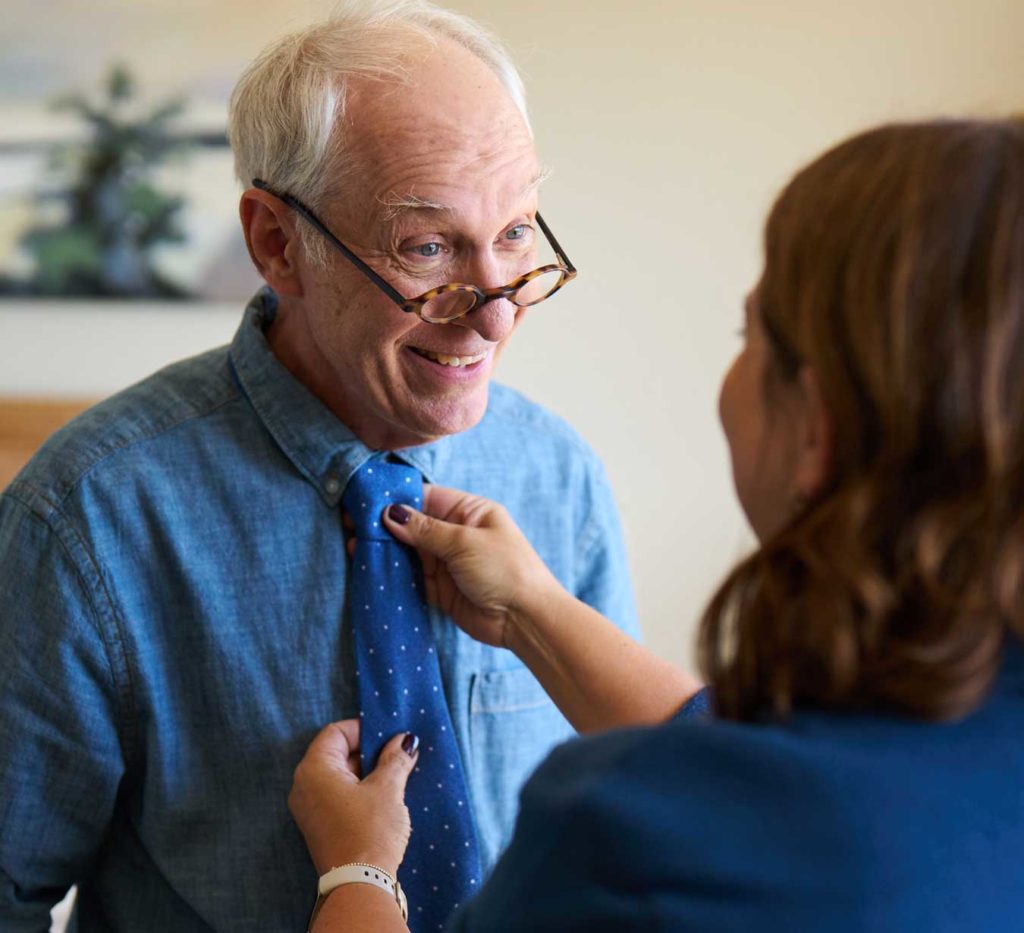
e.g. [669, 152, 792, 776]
[8, 0, 1024, 675]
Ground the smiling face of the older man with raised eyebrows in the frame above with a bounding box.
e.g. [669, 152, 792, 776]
[286, 43, 541, 450]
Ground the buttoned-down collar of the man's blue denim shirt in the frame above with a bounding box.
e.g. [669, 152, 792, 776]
[230, 287, 449, 508]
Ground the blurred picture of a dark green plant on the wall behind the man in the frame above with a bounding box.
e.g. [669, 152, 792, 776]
[0, 0, 268, 310]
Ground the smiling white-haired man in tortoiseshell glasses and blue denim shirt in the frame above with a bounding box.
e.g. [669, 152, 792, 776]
[0, 2, 635, 933]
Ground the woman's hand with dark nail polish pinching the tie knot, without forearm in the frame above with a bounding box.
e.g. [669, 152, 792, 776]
[384, 485, 561, 647]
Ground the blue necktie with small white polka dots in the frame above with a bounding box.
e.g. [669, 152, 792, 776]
[343, 461, 480, 933]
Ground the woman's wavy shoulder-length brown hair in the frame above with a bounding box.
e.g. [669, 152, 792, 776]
[699, 120, 1024, 720]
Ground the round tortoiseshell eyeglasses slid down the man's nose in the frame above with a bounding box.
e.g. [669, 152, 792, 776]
[253, 178, 577, 324]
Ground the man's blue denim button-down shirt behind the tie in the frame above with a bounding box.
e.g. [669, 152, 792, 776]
[0, 291, 636, 933]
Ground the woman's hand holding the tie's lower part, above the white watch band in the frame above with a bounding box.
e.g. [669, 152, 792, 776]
[288, 719, 419, 877]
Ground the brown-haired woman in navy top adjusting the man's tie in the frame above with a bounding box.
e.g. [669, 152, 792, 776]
[291, 120, 1024, 933]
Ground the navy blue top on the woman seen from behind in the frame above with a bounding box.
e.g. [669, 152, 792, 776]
[451, 644, 1024, 933]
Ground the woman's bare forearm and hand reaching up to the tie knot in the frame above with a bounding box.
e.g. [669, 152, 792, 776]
[384, 485, 700, 732]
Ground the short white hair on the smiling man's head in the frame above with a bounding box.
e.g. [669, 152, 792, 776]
[227, 0, 529, 258]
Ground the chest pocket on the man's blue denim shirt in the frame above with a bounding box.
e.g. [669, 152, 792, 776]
[469, 668, 575, 872]
